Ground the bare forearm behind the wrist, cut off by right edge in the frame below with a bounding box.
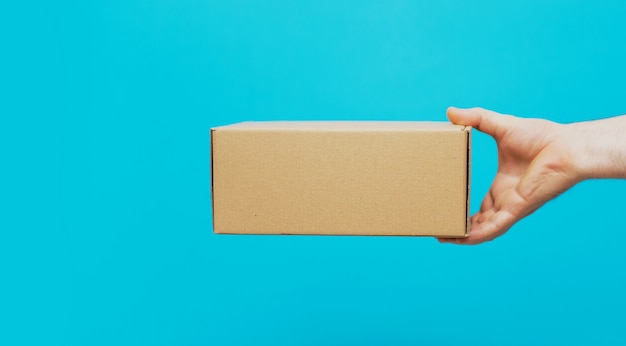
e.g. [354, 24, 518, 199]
[566, 115, 626, 179]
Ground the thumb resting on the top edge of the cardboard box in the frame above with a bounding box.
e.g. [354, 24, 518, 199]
[446, 107, 511, 137]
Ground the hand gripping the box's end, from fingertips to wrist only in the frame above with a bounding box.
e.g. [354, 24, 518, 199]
[439, 107, 583, 244]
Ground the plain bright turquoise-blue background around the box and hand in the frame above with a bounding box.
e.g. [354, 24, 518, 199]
[0, 0, 626, 345]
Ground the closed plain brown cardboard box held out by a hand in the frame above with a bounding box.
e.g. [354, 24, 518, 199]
[211, 121, 471, 237]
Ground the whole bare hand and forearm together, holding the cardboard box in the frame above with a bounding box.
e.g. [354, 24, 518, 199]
[439, 107, 626, 244]
